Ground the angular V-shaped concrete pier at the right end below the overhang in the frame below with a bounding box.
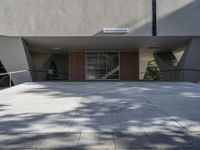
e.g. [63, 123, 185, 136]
[154, 38, 200, 82]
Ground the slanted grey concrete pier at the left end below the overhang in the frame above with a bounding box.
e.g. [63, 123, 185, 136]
[0, 37, 33, 84]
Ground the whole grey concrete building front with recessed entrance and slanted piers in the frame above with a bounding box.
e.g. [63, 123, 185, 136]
[0, 0, 200, 84]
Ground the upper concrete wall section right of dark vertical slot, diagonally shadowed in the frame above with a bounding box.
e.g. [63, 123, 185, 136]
[157, 0, 200, 36]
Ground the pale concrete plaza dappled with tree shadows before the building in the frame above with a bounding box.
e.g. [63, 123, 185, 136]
[0, 82, 200, 149]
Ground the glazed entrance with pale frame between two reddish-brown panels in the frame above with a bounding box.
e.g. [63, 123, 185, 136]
[85, 52, 120, 80]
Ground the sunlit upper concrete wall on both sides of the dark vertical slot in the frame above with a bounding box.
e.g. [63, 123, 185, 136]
[0, 0, 200, 36]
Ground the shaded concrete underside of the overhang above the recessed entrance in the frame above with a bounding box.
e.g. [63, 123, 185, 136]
[23, 36, 193, 52]
